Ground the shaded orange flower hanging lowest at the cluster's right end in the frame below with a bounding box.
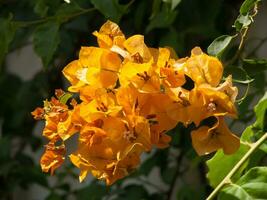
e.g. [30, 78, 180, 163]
[191, 117, 240, 155]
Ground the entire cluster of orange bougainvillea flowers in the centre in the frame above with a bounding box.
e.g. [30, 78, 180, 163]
[32, 21, 239, 184]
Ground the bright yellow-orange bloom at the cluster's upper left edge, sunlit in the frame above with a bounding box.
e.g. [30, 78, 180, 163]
[63, 47, 121, 92]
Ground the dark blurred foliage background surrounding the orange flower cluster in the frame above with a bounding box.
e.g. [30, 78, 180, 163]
[0, 0, 267, 200]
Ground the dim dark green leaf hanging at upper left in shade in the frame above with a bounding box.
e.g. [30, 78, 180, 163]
[33, 21, 60, 67]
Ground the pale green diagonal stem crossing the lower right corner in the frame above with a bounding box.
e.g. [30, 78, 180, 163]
[206, 133, 267, 200]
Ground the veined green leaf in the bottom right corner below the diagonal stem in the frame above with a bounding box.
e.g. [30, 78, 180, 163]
[218, 167, 267, 200]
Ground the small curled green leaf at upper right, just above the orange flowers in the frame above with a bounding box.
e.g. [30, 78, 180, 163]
[208, 35, 235, 57]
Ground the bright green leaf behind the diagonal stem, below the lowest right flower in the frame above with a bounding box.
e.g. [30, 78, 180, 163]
[207, 144, 249, 187]
